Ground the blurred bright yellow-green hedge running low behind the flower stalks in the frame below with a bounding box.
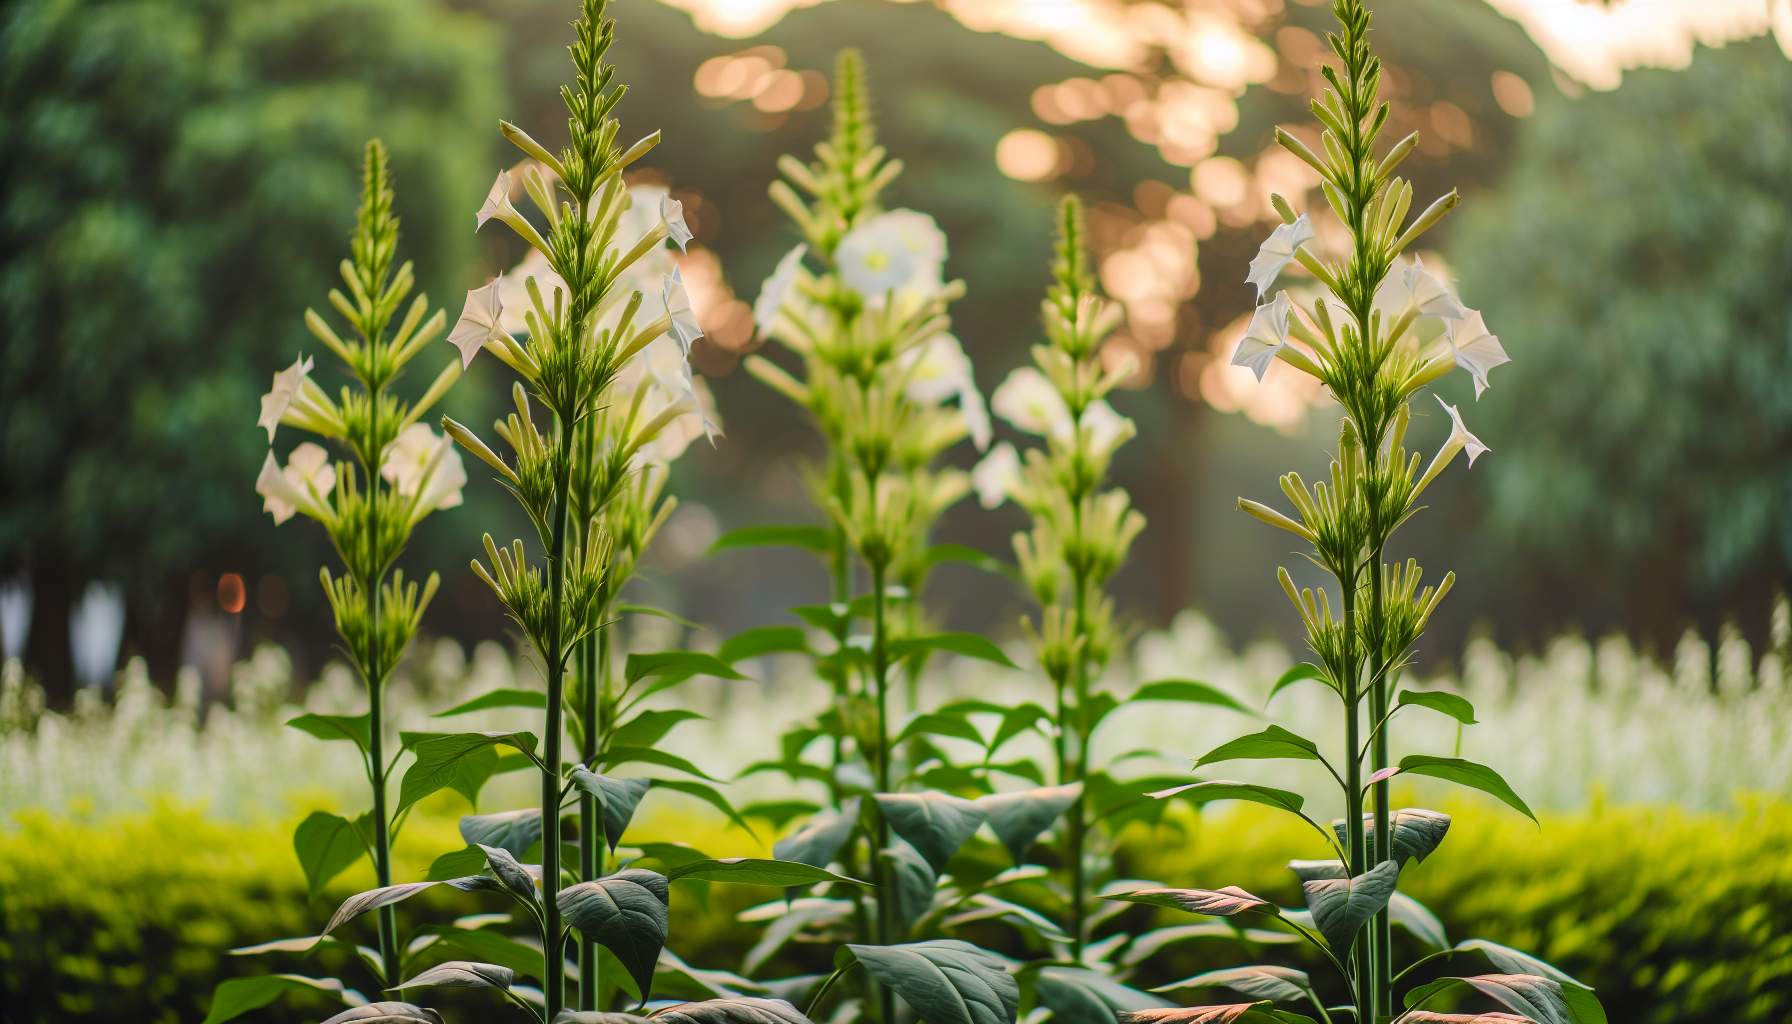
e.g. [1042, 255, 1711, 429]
[0, 803, 1792, 1024]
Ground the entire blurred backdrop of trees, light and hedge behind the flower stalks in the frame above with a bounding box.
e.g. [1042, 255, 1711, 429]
[0, 0, 1792, 1024]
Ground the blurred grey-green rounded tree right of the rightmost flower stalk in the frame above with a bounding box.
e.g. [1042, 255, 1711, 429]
[1452, 38, 1792, 640]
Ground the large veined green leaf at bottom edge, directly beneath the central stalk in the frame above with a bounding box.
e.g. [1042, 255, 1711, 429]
[846, 940, 1020, 1024]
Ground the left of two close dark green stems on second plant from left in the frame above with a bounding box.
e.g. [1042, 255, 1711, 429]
[541, 451, 572, 1020]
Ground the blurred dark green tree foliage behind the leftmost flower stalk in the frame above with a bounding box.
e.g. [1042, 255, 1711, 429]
[0, 0, 496, 706]
